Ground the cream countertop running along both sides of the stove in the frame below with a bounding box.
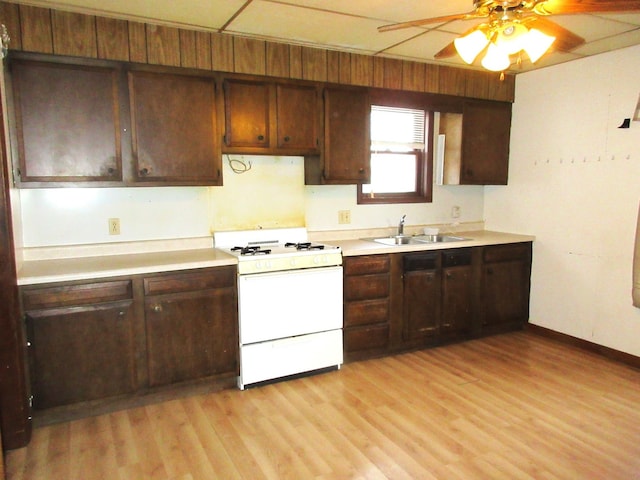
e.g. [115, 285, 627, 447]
[18, 230, 535, 285]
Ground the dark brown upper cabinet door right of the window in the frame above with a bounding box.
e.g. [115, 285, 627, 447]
[460, 101, 511, 185]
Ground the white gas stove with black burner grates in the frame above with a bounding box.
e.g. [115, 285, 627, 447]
[214, 228, 343, 389]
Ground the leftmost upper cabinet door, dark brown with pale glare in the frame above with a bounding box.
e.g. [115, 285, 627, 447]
[10, 60, 122, 186]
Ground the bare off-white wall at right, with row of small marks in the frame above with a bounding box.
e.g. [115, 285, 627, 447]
[485, 46, 640, 356]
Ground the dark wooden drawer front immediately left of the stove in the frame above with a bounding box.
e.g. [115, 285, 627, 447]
[144, 267, 236, 295]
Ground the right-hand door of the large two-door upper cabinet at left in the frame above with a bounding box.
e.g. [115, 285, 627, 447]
[129, 71, 222, 185]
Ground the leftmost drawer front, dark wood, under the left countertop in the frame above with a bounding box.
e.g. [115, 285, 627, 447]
[22, 280, 132, 311]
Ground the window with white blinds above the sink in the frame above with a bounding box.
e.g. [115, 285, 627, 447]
[358, 105, 431, 203]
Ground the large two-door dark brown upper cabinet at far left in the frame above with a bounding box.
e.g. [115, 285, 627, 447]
[9, 55, 222, 187]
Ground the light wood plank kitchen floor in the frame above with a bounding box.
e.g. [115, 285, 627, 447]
[6, 332, 640, 480]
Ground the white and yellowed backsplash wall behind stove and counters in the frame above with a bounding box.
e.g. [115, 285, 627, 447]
[14, 155, 484, 248]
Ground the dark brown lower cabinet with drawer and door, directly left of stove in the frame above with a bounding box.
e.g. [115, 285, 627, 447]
[144, 267, 238, 387]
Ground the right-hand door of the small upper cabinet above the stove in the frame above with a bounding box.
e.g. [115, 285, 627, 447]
[276, 85, 319, 151]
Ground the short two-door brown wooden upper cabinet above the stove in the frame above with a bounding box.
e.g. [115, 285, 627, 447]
[223, 79, 321, 155]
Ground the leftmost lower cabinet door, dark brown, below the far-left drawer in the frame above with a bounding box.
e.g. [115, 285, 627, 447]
[27, 300, 136, 409]
